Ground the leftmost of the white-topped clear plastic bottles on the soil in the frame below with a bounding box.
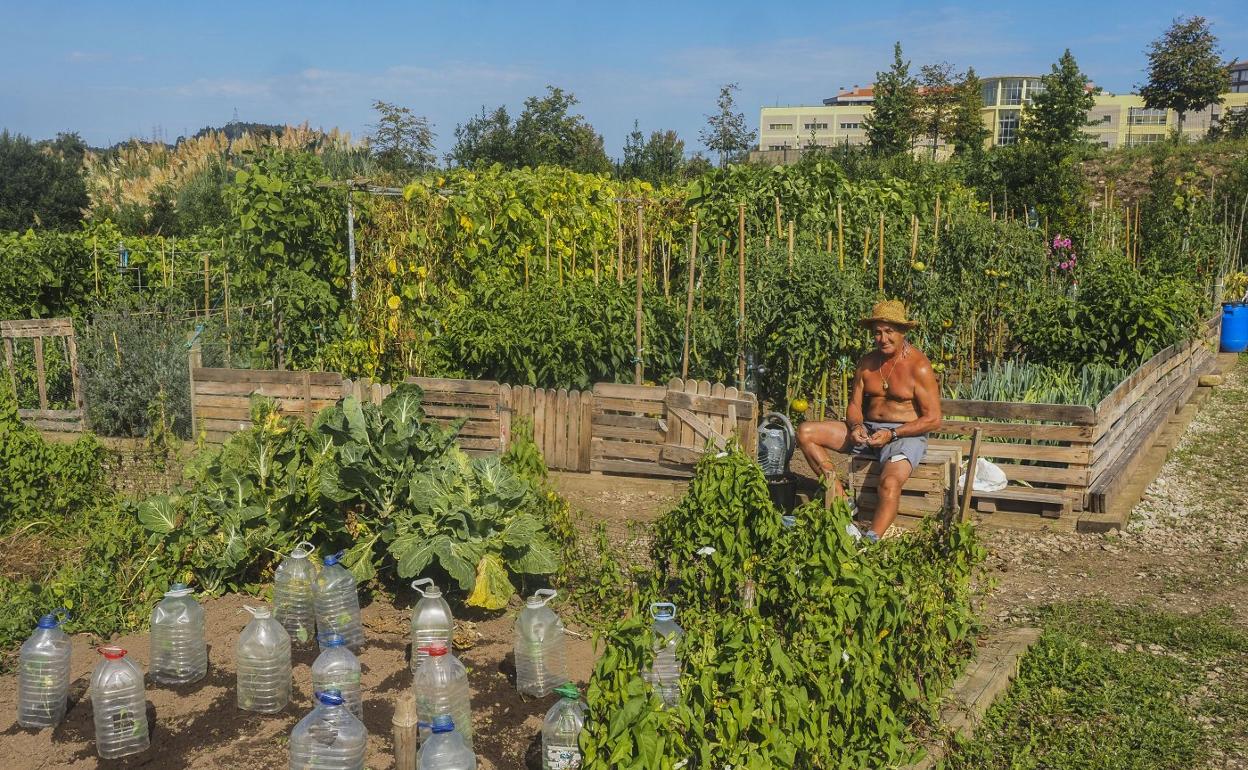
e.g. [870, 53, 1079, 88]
[236, 607, 291, 714]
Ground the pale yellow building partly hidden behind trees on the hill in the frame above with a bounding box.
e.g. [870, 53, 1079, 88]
[751, 75, 1248, 162]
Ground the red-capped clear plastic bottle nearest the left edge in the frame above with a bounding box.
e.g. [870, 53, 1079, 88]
[91, 646, 151, 759]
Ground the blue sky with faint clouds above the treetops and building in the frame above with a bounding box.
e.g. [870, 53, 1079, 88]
[0, 0, 1248, 156]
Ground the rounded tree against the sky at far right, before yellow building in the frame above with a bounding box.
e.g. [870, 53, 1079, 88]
[1139, 16, 1231, 139]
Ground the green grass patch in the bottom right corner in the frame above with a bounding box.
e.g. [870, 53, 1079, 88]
[941, 602, 1248, 770]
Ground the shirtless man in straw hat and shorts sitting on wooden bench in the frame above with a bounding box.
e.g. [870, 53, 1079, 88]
[797, 300, 941, 542]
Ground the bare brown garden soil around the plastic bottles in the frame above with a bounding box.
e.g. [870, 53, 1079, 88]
[0, 595, 594, 770]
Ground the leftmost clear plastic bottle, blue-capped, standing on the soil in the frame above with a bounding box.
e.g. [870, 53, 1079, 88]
[17, 614, 71, 729]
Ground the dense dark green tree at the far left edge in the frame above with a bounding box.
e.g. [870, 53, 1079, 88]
[0, 131, 89, 230]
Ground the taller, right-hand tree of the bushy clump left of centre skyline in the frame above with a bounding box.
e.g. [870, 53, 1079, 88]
[515, 86, 612, 173]
